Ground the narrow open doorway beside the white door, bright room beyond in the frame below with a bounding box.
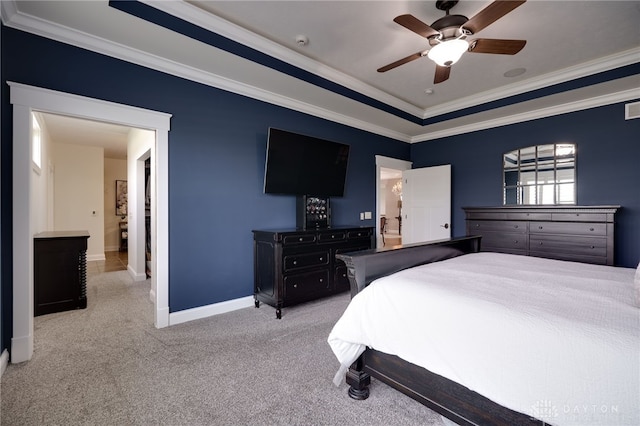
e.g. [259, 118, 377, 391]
[376, 155, 411, 248]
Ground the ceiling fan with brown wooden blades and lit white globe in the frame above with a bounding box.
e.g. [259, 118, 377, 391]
[378, 0, 527, 84]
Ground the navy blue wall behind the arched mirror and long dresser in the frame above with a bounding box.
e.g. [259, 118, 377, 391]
[411, 104, 640, 267]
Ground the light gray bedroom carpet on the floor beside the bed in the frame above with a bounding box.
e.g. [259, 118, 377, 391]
[0, 271, 442, 425]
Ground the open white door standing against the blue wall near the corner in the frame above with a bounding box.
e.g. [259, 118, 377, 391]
[401, 164, 451, 245]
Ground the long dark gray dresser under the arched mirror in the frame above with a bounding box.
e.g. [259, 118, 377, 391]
[463, 206, 620, 265]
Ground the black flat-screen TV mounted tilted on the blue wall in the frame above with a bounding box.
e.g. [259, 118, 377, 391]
[264, 128, 350, 197]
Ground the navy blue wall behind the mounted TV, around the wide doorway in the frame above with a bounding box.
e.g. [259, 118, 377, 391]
[1, 27, 410, 347]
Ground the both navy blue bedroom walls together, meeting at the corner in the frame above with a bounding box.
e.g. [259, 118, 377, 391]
[0, 23, 640, 356]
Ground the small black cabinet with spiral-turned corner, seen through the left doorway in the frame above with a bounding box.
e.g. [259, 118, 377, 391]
[33, 231, 89, 316]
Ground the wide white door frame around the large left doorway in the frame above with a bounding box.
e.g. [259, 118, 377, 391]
[7, 81, 171, 363]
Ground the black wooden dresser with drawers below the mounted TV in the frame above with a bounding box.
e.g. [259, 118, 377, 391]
[253, 227, 375, 318]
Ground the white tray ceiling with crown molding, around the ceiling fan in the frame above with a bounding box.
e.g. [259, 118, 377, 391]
[2, 0, 640, 148]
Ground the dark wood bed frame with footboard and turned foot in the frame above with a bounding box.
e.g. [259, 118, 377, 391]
[336, 236, 547, 426]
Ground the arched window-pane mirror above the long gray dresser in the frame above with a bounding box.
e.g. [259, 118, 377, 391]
[502, 143, 576, 206]
